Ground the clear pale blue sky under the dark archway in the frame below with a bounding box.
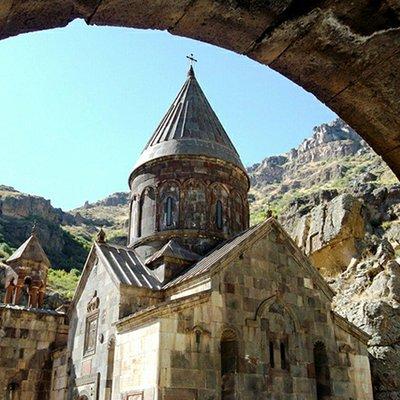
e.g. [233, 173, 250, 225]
[0, 21, 335, 210]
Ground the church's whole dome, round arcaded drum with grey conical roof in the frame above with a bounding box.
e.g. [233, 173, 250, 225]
[128, 68, 249, 262]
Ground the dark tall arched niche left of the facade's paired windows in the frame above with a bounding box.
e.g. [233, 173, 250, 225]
[221, 329, 238, 400]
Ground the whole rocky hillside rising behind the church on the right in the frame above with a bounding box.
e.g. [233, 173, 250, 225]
[249, 120, 400, 400]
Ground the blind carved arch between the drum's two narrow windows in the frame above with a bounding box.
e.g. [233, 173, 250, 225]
[180, 178, 208, 229]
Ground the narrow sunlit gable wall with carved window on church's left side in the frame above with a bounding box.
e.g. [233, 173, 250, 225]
[67, 260, 120, 399]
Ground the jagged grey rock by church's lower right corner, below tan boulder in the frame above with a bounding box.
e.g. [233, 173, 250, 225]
[331, 240, 400, 400]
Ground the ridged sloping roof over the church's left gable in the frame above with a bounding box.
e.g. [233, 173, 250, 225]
[96, 243, 161, 290]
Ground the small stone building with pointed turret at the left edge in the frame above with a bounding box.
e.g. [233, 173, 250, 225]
[0, 232, 68, 400]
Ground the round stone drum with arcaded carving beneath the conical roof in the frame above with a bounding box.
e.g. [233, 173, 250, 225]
[130, 156, 249, 258]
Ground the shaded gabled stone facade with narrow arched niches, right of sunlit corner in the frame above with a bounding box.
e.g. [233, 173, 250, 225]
[150, 225, 372, 400]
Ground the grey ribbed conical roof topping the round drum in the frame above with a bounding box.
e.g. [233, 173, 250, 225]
[135, 68, 245, 171]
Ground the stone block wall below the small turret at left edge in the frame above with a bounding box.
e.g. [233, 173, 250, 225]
[0, 305, 68, 400]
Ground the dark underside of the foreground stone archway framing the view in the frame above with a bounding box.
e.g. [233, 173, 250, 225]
[0, 0, 400, 177]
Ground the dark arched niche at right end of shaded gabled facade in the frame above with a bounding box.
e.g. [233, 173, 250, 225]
[314, 341, 332, 400]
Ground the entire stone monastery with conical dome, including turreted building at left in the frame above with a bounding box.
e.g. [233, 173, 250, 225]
[0, 67, 373, 400]
